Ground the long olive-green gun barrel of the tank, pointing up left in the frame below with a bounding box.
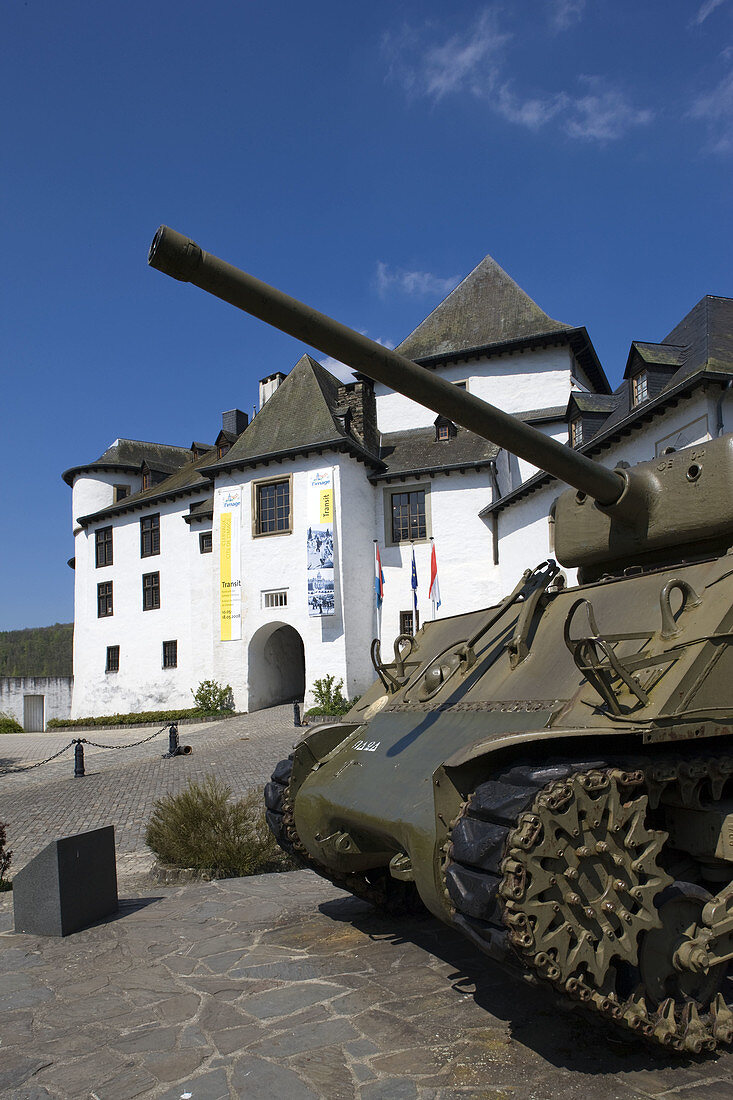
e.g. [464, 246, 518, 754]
[147, 226, 626, 507]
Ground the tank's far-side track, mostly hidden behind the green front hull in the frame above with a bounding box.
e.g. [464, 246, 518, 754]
[264, 756, 426, 917]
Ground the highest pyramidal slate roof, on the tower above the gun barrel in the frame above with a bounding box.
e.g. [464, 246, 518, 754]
[397, 256, 572, 359]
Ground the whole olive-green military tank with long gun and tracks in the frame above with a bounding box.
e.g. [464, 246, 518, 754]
[149, 227, 733, 1053]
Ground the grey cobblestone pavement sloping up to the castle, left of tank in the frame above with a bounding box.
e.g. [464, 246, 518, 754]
[0, 706, 303, 879]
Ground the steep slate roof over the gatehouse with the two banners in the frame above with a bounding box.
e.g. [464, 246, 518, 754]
[200, 354, 379, 474]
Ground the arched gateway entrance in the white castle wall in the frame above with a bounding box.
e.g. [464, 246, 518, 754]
[248, 623, 305, 711]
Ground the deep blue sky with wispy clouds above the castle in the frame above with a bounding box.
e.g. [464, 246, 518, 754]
[0, 0, 733, 629]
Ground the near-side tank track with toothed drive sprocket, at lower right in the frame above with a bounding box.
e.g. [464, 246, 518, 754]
[444, 756, 733, 1053]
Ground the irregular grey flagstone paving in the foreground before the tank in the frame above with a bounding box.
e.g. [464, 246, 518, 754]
[0, 871, 733, 1100]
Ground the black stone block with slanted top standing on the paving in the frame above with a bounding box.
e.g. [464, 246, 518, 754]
[13, 825, 119, 936]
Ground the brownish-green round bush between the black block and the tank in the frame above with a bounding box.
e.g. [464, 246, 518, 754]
[145, 776, 295, 879]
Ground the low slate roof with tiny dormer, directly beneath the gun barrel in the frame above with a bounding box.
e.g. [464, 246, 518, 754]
[370, 426, 499, 481]
